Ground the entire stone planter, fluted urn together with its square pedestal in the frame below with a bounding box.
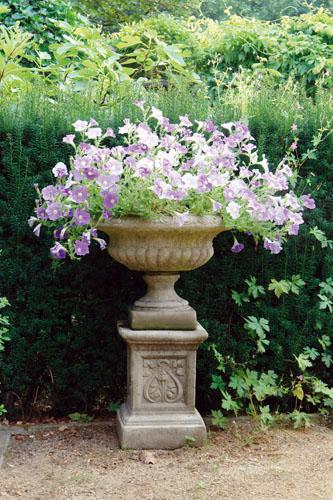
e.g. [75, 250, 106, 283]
[99, 216, 227, 449]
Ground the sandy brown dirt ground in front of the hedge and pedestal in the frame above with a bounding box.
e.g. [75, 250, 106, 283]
[0, 422, 333, 500]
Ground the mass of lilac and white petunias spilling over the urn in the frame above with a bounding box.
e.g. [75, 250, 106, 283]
[29, 101, 315, 259]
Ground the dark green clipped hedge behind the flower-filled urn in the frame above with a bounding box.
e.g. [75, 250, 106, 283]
[0, 83, 333, 417]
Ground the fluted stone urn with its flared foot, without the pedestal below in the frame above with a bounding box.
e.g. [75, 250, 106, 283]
[98, 216, 227, 330]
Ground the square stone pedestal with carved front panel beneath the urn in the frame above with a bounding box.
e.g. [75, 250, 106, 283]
[117, 322, 208, 449]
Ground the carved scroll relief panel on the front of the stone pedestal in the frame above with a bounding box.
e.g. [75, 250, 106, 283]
[143, 358, 185, 403]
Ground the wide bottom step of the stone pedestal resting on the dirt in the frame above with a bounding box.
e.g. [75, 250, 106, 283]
[117, 403, 207, 450]
